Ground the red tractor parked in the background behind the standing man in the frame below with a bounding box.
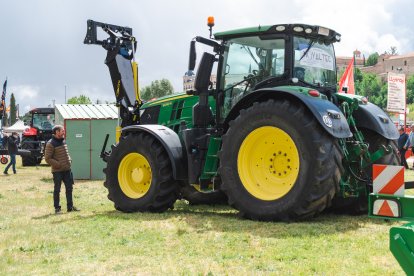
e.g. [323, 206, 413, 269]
[21, 107, 55, 166]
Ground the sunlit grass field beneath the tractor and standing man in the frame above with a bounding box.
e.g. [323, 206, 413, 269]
[0, 157, 408, 275]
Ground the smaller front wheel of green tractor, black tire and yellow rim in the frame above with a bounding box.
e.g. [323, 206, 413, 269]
[104, 133, 179, 212]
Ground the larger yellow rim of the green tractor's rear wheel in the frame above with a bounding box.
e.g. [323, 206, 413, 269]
[237, 126, 300, 201]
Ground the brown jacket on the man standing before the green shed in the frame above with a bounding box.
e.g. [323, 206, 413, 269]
[45, 137, 72, 172]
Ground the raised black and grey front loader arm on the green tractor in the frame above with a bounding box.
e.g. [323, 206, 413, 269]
[84, 20, 142, 127]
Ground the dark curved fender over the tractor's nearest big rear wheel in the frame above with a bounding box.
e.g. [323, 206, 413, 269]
[225, 89, 352, 138]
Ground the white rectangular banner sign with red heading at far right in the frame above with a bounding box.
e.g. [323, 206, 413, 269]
[387, 73, 406, 114]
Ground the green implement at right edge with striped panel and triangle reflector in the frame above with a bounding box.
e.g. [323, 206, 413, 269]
[368, 164, 414, 275]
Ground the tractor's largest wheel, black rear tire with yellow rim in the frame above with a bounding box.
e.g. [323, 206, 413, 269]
[219, 100, 341, 221]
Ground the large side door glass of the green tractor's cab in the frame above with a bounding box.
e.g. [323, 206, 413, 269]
[222, 36, 285, 115]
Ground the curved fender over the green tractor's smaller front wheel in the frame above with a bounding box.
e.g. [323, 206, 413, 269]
[122, 125, 187, 180]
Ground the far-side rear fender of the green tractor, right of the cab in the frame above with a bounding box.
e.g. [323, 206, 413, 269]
[353, 103, 400, 140]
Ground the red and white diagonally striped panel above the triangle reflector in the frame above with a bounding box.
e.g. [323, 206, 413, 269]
[372, 164, 405, 196]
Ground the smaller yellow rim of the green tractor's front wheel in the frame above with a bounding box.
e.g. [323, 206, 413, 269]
[118, 152, 152, 199]
